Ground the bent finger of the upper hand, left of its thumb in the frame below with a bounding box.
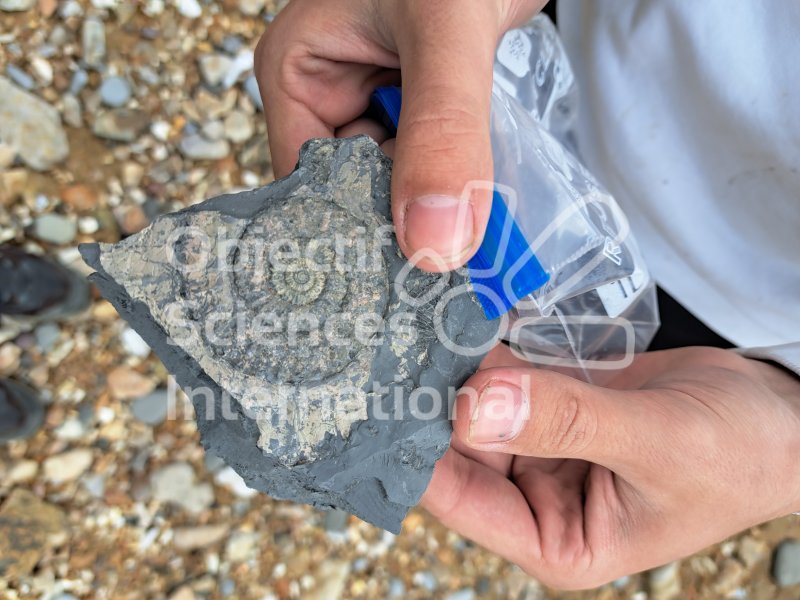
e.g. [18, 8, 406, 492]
[255, 2, 399, 177]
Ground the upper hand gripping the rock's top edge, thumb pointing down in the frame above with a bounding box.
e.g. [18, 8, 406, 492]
[256, 0, 546, 271]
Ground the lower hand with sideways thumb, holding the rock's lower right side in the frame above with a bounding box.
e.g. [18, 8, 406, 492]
[423, 346, 800, 589]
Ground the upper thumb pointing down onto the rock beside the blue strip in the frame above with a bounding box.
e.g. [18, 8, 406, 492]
[392, 0, 502, 271]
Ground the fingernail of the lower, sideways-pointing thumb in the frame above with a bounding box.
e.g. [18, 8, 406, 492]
[469, 383, 529, 444]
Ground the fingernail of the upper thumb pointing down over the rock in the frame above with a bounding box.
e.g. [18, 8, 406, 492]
[405, 195, 474, 263]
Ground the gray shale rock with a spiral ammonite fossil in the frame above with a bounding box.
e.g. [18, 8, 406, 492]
[81, 136, 498, 532]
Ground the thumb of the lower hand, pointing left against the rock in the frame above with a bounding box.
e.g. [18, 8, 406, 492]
[453, 367, 663, 470]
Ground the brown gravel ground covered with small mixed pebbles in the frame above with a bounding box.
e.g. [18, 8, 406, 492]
[0, 0, 800, 600]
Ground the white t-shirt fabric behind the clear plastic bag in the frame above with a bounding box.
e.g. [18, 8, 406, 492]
[558, 0, 800, 346]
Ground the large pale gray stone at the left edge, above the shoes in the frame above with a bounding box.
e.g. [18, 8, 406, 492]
[0, 77, 69, 171]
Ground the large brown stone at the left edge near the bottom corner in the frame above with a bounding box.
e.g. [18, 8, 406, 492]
[0, 488, 67, 582]
